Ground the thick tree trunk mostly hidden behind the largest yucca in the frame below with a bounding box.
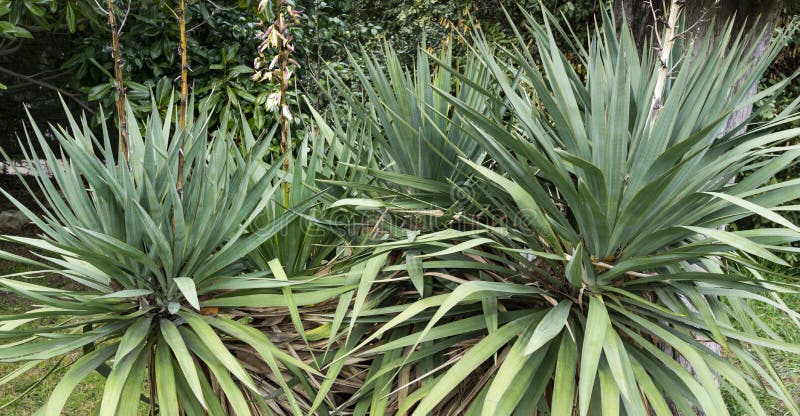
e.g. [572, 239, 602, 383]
[614, 0, 782, 415]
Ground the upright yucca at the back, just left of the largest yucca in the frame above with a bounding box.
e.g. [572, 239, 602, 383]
[328, 42, 500, 204]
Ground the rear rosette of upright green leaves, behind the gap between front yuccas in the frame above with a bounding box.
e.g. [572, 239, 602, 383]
[312, 42, 504, 235]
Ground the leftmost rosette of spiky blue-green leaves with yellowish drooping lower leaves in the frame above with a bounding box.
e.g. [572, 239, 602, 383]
[0, 102, 328, 415]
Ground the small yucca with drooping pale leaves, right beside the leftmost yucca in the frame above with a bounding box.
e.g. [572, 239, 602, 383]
[200, 114, 390, 415]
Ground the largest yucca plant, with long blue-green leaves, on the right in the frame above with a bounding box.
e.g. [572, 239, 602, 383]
[334, 7, 800, 416]
